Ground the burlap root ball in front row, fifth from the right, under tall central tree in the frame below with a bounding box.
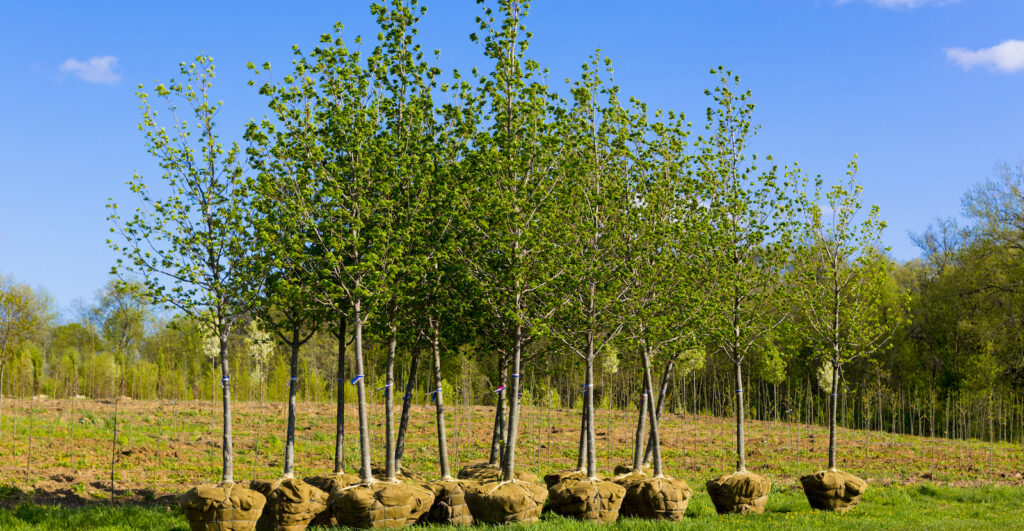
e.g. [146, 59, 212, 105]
[466, 480, 548, 524]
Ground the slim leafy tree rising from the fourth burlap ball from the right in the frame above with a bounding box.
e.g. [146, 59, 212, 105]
[550, 55, 630, 479]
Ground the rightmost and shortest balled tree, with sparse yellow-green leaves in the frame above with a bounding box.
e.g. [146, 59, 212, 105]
[794, 160, 908, 470]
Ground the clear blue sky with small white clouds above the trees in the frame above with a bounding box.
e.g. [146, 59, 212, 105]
[0, 0, 1024, 307]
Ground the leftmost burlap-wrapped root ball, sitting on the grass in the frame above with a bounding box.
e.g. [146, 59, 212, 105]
[180, 483, 266, 531]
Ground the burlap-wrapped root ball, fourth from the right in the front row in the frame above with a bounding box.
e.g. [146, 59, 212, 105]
[548, 477, 626, 522]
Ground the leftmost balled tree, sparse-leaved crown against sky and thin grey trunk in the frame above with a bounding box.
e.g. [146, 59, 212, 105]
[108, 55, 262, 483]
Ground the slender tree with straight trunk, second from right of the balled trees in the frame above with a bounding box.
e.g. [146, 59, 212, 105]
[700, 67, 801, 472]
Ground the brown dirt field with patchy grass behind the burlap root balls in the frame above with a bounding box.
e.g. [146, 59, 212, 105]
[0, 399, 1024, 505]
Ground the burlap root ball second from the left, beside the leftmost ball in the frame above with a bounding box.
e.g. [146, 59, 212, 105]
[251, 478, 327, 531]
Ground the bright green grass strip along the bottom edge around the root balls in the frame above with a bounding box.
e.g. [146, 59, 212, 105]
[0, 485, 1024, 531]
